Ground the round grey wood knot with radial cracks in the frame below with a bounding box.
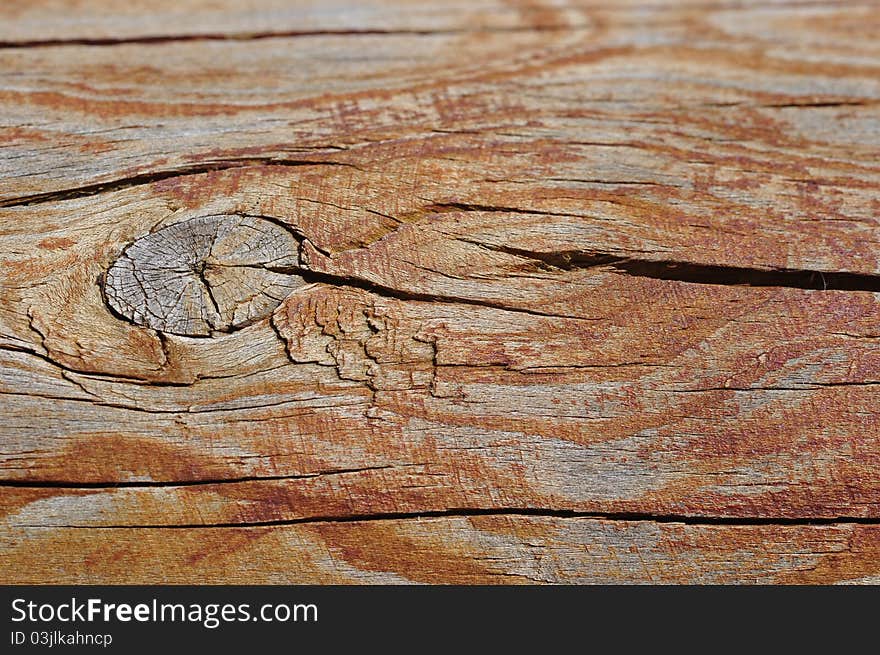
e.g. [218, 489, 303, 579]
[104, 215, 305, 337]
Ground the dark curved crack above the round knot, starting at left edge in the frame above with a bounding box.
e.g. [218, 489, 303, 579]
[0, 157, 352, 207]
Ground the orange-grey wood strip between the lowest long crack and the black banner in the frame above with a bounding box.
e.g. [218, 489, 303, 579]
[0, 516, 880, 584]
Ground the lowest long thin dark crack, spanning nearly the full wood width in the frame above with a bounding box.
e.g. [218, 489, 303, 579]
[18, 507, 880, 530]
